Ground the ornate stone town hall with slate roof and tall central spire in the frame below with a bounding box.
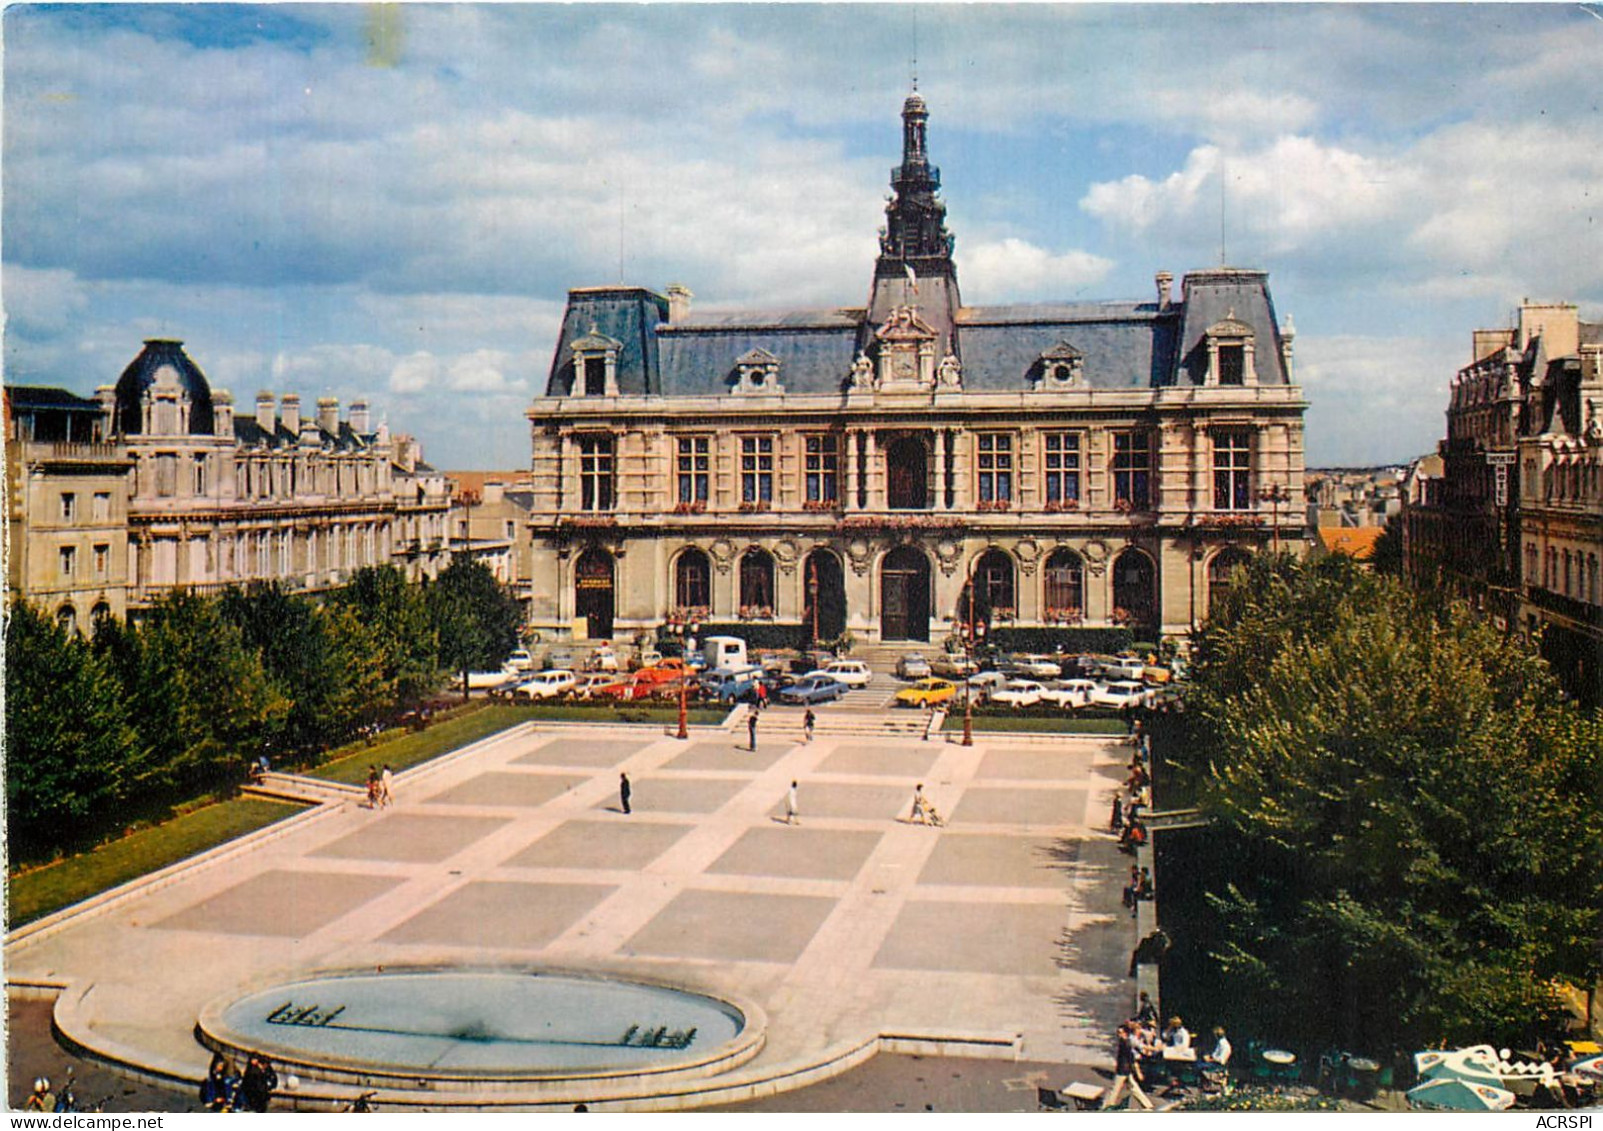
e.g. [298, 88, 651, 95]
[529, 93, 1305, 641]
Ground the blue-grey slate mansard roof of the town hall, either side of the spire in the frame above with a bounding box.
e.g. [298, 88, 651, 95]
[547, 268, 1287, 396]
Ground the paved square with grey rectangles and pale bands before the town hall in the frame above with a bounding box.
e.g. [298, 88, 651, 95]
[6, 710, 1133, 1101]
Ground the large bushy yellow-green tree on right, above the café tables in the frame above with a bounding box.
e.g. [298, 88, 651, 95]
[1188, 557, 1603, 1051]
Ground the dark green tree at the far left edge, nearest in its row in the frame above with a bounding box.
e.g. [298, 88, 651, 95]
[5, 602, 139, 860]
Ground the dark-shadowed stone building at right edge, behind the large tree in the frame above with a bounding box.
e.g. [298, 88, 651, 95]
[1404, 301, 1603, 703]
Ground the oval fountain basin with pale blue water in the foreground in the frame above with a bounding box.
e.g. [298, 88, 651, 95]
[197, 969, 761, 1083]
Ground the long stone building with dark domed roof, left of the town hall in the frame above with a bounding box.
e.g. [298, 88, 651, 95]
[6, 340, 449, 628]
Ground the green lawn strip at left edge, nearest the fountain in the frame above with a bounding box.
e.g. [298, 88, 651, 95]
[6, 798, 301, 928]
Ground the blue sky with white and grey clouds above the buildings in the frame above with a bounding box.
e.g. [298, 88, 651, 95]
[0, 3, 1603, 469]
